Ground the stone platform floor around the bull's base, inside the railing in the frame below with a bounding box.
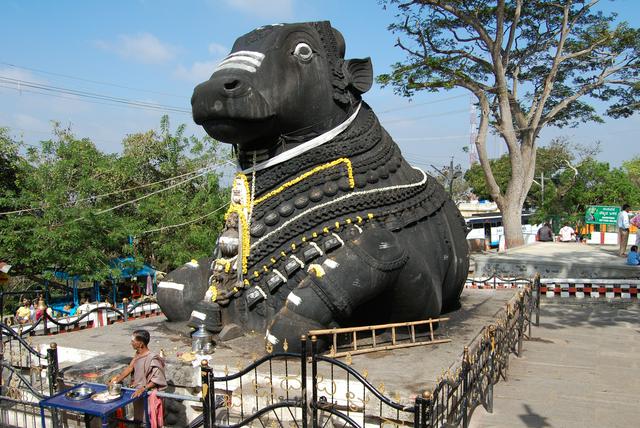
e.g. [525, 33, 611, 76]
[31, 289, 516, 400]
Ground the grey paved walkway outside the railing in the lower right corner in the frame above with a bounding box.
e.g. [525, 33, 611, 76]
[471, 300, 640, 428]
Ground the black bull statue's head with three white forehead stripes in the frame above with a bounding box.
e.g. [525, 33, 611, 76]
[191, 21, 373, 166]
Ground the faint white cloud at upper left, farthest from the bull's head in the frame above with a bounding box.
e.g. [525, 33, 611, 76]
[95, 33, 178, 64]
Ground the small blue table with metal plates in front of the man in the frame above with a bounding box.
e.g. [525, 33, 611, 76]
[39, 383, 149, 428]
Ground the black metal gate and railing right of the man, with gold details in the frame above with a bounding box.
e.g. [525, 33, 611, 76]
[196, 276, 540, 428]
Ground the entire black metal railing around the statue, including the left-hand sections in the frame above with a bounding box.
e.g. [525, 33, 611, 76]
[0, 277, 540, 428]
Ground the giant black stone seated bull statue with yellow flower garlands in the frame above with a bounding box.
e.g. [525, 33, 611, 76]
[158, 22, 469, 350]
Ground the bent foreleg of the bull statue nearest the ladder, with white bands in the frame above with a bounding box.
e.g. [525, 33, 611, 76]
[266, 228, 408, 352]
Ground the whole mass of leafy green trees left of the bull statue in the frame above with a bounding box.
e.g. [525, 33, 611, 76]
[0, 117, 228, 280]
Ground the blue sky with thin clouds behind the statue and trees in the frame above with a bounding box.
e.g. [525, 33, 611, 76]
[0, 0, 640, 170]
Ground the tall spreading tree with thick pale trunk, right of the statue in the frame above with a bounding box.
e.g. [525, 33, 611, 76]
[378, 0, 640, 247]
